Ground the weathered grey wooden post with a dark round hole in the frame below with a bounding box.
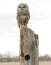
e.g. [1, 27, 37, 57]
[20, 25, 39, 65]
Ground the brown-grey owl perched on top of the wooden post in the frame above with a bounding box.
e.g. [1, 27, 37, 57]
[16, 3, 30, 27]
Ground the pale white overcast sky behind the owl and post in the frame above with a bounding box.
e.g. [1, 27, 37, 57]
[0, 0, 51, 56]
